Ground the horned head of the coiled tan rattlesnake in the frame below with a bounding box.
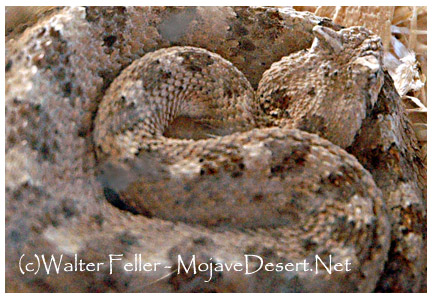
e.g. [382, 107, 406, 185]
[257, 26, 384, 148]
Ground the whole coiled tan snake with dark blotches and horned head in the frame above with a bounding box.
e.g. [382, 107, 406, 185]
[6, 7, 426, 292]
